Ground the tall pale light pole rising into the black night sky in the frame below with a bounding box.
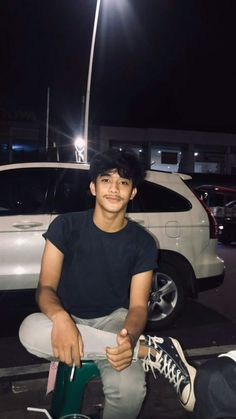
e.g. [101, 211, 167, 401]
[83, 0, 101, 163]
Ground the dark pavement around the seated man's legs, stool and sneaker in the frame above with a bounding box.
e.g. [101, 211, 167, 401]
[0, 300, 236, 419]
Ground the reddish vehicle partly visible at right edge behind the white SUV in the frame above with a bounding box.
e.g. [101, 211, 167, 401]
[196, 185, 236, 244]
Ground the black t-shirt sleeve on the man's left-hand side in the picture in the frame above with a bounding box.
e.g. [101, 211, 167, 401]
[43, 215, 68, 253]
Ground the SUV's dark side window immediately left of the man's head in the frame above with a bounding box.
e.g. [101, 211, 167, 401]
[53, 169, 94, 214]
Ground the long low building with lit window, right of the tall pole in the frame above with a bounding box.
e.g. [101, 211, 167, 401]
[97, 126, 236, 175]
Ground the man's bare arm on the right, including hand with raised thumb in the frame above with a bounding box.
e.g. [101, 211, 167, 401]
[107, 271, 153, 371]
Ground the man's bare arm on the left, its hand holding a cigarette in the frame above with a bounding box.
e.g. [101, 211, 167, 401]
[36, 240, 83, 366]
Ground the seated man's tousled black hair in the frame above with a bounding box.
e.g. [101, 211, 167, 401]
[89, 149, 145, 187]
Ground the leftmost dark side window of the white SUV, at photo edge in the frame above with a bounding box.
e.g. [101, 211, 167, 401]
[0, 168, 50, 216]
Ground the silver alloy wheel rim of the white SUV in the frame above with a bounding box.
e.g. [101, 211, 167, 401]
[148, 273, 178, 321]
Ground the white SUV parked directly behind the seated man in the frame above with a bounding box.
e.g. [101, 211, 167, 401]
[0, 163, 224, 327]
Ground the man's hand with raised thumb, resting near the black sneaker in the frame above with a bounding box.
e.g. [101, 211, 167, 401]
[106, 329, 134, 371]
